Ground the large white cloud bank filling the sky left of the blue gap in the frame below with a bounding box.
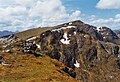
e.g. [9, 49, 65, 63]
[0, 0, 81, 31]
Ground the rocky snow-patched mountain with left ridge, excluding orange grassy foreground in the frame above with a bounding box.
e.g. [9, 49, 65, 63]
[1, 20, 120, 82]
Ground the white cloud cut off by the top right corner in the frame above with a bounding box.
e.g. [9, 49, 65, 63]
[96, 0, 120, 9]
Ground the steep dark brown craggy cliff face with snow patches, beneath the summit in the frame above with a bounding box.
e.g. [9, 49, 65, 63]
[38, 21, 120, 82]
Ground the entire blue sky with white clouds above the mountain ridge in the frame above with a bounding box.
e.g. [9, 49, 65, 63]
[0, 0, 120, 31]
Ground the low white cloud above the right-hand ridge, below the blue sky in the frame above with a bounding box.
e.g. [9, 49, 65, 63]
[86, 14, 120, 29]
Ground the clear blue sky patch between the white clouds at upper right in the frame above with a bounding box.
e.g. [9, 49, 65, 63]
[62, 0, 120, 18]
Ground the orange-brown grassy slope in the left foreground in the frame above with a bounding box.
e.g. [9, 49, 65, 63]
[0, 53, 76, 82]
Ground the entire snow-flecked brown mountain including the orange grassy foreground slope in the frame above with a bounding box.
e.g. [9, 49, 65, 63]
[0, 20, 120, 82]
